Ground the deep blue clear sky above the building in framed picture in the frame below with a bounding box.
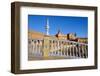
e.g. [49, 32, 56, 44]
[28, 15, 88, 37]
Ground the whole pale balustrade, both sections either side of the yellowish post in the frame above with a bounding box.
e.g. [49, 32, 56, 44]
[28, 39, 88, 58]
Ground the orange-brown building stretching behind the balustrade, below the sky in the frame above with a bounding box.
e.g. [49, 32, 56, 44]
[28, 30, 88, 43]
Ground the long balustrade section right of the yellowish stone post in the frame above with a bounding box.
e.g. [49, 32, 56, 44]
[49, 40, 88, 58]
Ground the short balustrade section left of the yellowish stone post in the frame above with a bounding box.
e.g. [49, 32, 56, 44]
[28, 39, 43, 57]
